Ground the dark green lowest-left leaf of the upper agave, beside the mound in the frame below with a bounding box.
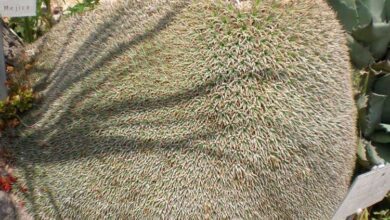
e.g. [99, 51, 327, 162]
[348, 36, 375, 69]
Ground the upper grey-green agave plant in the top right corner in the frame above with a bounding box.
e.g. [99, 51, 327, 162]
[329, 0, 390, 68]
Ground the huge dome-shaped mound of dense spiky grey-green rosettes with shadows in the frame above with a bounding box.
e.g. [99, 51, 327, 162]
[10, 0, 356, 219]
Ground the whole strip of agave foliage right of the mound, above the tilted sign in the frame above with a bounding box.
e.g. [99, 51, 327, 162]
[329, 0, 390, 167]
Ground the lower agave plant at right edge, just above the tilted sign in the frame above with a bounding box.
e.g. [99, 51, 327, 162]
[358, 71, 390, 165]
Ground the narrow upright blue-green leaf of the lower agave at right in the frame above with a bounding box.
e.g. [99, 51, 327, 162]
[362, 93, 387, 137]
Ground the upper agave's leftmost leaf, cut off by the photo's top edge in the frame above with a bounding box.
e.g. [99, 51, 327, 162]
[328, 0, 358, 33]
